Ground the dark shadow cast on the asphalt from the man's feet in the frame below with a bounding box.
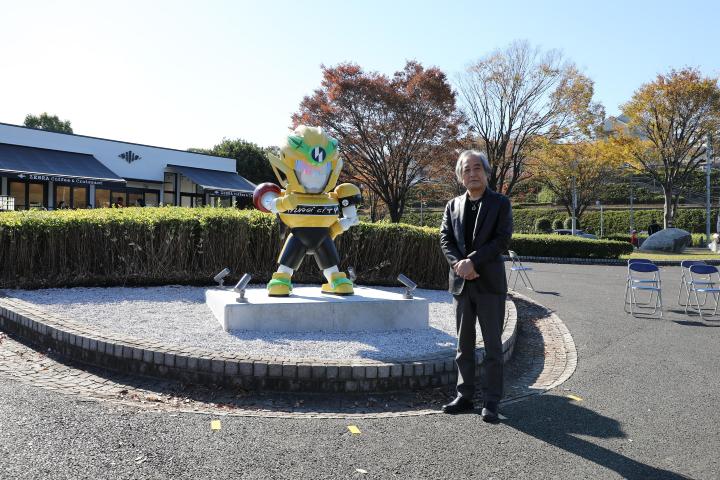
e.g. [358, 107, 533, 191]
[503, 395, 689, 480]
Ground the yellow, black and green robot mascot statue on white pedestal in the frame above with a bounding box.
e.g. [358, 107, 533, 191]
[253, 125, 362, 297]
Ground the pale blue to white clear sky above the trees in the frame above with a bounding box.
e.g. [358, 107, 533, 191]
[0, 0, 720, 149]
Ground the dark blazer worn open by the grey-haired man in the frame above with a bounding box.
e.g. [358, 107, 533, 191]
[440, 189, 513, 295]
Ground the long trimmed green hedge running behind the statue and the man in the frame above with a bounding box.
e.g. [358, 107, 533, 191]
[0, 207, 631, 288]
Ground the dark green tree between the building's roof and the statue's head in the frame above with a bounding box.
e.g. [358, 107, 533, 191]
[189, 138, 277, 184]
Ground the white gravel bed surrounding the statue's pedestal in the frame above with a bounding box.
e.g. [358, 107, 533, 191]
[6, 285, 457, 360]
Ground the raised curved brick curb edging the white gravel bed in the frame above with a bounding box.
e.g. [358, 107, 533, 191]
[0, 294, 517, 393]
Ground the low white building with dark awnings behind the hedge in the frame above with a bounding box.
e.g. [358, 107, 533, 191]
[0, 123, 255, 210]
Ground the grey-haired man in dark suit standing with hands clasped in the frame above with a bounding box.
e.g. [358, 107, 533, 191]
[440, 150, 513, 423]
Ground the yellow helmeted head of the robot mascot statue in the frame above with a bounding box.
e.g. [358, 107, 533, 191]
[270, 125, 342, 193]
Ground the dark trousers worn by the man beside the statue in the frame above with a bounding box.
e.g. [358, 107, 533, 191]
[453, 281, 506, 402]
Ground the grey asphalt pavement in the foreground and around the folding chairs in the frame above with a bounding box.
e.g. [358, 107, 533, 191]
[0, 264, 720, 479]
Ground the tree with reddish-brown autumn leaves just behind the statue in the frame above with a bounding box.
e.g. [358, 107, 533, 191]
[293, 61, 461, 222]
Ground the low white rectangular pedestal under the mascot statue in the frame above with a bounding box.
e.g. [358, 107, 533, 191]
[205, 286, 429, 332]
